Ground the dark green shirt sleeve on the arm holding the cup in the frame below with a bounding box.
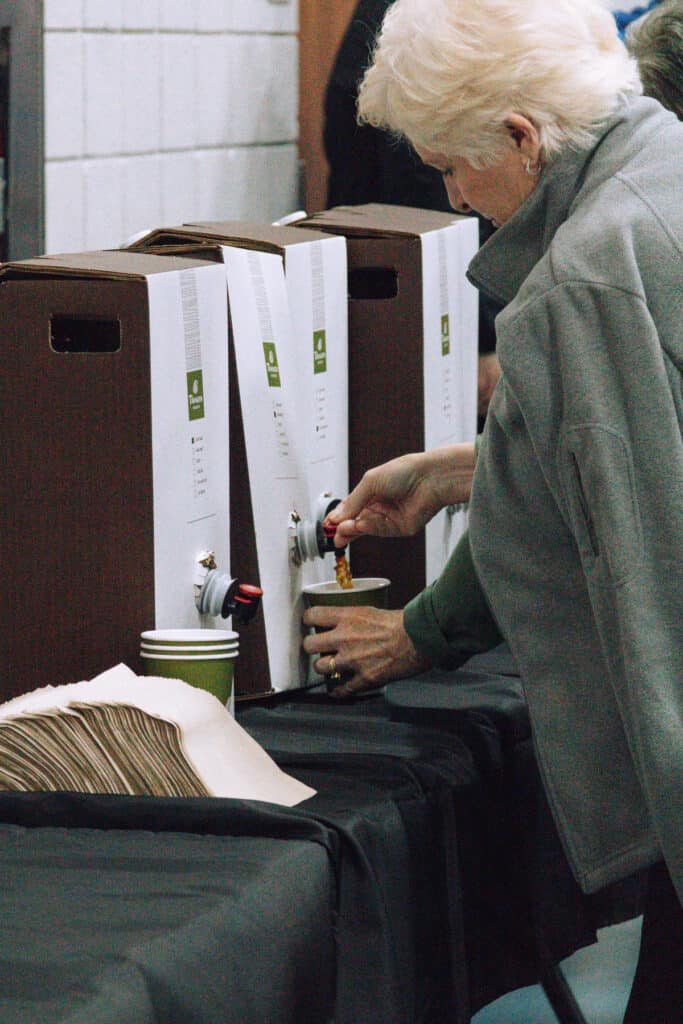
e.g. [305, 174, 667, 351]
[403, 532, 504, 669]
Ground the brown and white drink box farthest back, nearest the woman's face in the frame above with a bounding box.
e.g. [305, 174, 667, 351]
[295, 204, 478, 607]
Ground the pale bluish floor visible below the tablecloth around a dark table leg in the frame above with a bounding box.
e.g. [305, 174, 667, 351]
[472, 919, 640, 1024]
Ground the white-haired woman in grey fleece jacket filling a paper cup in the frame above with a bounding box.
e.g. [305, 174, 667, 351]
[305, 0, 683, 1024]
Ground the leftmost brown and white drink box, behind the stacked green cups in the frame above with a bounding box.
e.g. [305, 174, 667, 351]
[0, 252, 229, 698]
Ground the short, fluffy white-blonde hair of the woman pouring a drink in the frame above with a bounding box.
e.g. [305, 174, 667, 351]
[358, 0, 642, 167]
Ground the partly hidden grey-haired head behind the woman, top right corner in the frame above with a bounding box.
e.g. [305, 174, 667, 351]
[626, 0, 683, 121]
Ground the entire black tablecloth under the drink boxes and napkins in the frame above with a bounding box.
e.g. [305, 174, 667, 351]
[0, 651, 638, 1024]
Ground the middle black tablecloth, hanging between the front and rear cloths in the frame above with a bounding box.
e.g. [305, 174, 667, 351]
[240, 696, 479, 1024]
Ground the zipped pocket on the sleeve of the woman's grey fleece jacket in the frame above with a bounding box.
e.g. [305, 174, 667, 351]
[559, 424, 643, 587]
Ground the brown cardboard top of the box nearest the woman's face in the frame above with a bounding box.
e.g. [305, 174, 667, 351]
[303, 203, 463, 238]
